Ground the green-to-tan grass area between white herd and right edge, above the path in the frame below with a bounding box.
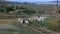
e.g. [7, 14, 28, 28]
[30, 17, 60, 32]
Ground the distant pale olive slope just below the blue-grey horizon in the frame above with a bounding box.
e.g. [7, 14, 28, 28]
[8, 4, 60, 11]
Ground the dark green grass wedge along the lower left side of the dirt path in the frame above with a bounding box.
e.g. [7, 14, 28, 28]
[15, 25, 40, 34]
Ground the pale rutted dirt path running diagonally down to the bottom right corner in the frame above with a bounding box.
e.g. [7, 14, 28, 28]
[23, 25, 60, 34]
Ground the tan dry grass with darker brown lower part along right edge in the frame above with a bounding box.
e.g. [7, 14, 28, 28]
[46, 18, 60, 31]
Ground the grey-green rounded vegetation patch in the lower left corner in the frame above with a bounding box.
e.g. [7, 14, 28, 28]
[0, 24, 20, 34]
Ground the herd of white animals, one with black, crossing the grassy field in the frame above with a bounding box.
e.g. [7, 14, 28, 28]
[18, 16, 47, 24]
